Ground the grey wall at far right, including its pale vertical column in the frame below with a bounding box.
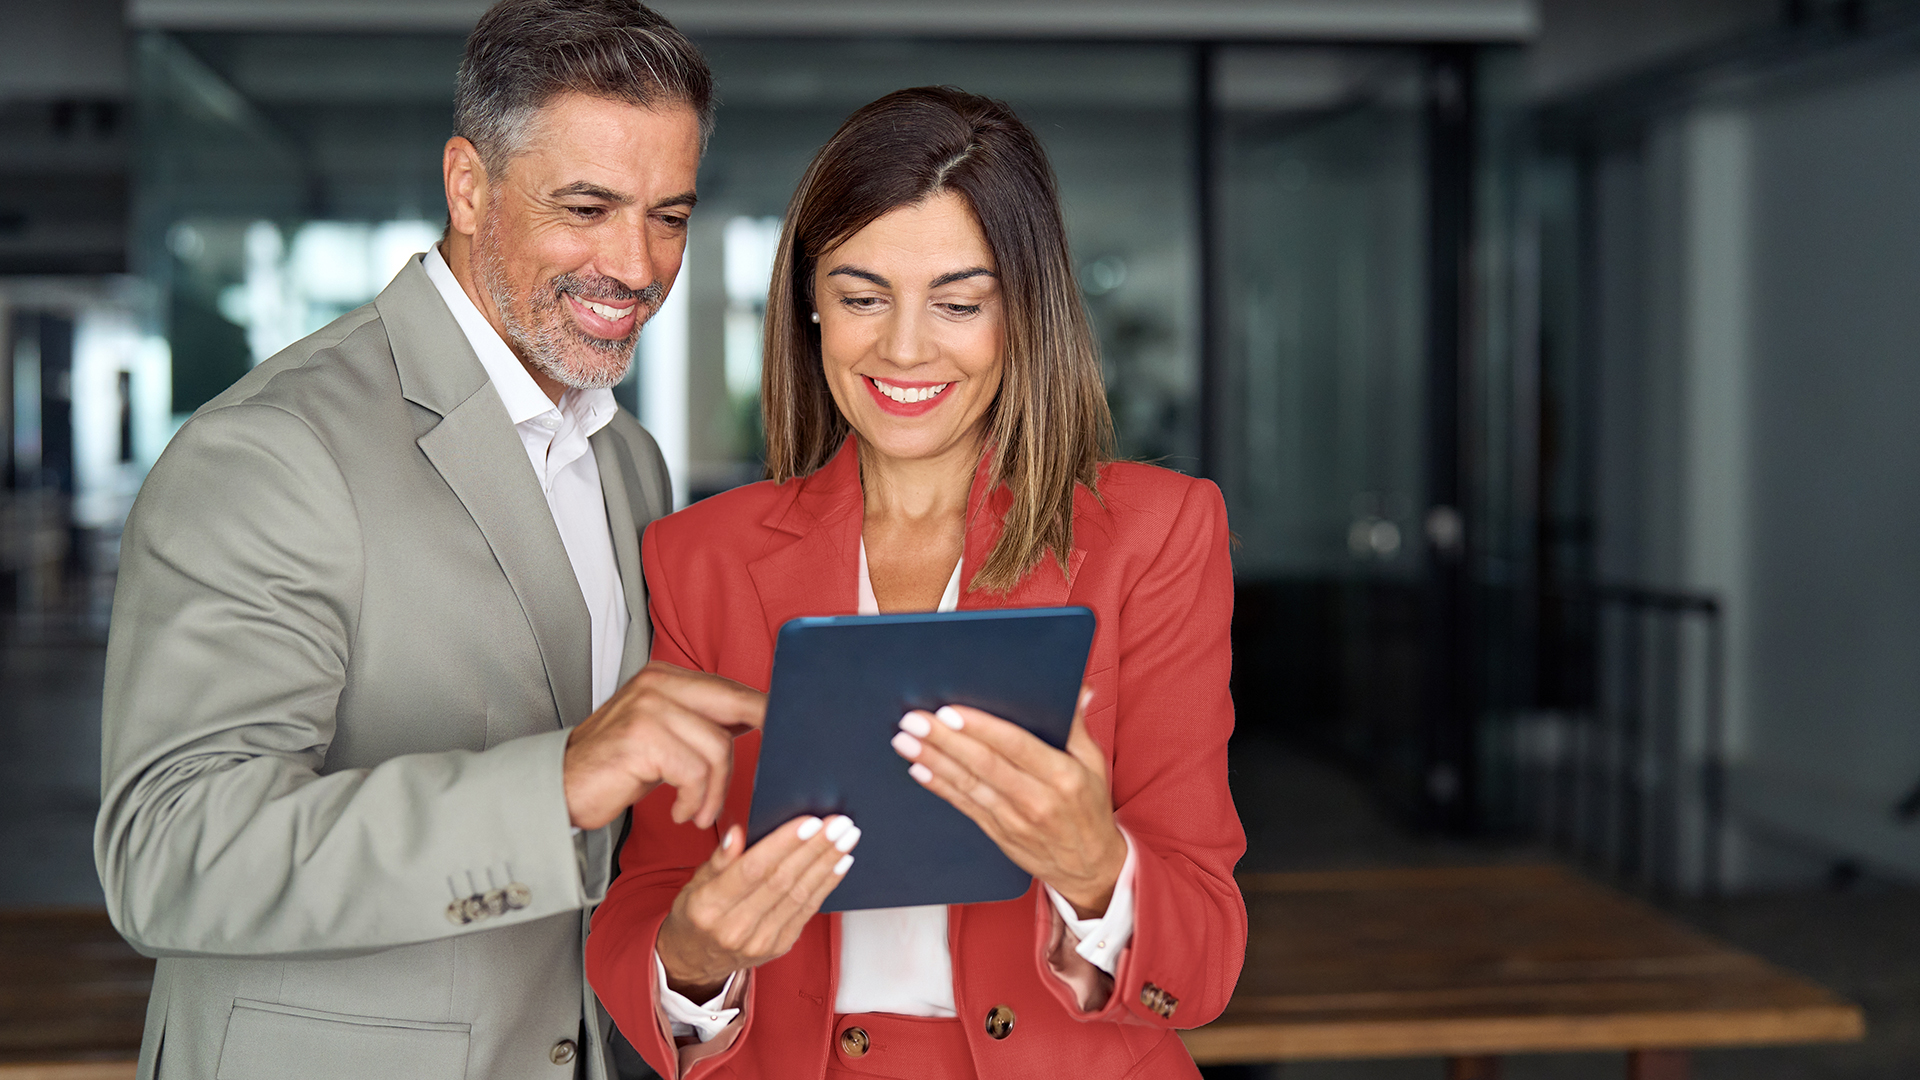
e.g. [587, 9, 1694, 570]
[1592, 60, 1920, 888]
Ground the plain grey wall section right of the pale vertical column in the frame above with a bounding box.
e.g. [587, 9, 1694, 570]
[1743, 67, 1920, 872]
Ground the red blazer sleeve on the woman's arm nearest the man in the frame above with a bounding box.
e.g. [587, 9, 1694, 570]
[586, 525, 753, 1078]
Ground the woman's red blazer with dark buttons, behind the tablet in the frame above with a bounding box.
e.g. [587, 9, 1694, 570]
[586, 440, 1246, 1080]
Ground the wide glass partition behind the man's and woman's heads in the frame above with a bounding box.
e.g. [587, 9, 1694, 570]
[136, 33, 1200, 500]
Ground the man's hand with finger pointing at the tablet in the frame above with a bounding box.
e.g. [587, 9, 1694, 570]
[563, 661, 766, 828]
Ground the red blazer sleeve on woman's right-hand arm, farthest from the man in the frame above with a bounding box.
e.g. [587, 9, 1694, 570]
[1037, 480, 1246, 1028]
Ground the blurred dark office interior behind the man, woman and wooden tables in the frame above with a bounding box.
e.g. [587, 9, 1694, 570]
[0, 0, 1920, 1076]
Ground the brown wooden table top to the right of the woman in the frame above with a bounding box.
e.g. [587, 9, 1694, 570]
[1185, 867, 1864, 1080]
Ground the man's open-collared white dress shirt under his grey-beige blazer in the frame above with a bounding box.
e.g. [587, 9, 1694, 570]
[424, 244, 628, 709]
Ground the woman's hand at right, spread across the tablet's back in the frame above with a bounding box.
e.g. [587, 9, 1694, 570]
[893, 686, 1127, 919]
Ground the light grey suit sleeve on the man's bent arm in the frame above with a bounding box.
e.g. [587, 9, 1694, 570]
[94, 404, 605, 957]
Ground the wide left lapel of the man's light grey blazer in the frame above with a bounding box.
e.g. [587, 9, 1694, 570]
[385, 259, 595, 726]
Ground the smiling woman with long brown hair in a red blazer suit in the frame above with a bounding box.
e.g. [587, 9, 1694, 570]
[588, 88, 1246, 1080]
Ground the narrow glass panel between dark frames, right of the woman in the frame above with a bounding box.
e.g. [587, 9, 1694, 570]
[1215, 48, 1427, 578]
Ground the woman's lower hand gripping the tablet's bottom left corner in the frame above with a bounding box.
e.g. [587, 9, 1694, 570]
[655, 817, 860, 1001]
